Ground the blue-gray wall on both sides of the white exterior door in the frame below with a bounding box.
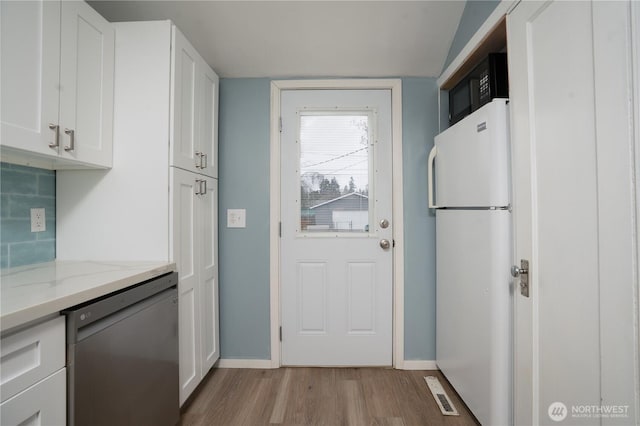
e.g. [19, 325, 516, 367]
[219, 78, 438, 360]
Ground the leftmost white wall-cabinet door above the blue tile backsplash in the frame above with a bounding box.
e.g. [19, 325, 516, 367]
[0, 1, 60, 156]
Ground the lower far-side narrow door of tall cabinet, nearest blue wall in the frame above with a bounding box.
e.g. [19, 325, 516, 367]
[197, 176, 220, 376]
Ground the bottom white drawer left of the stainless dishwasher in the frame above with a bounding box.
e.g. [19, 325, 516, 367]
[0, 368, 67, 426]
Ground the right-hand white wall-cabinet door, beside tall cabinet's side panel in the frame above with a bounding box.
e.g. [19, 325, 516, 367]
[60, 1, 115, 167]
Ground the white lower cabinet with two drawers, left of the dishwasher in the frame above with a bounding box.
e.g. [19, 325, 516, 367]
[0, 316, 67, 426]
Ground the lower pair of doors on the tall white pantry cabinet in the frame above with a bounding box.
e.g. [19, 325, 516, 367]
[171, 167, 220, 402]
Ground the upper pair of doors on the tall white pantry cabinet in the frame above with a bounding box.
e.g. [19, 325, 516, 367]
[171, 27, 218, 177]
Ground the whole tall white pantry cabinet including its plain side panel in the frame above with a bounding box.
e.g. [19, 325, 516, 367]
[56, 21, 220, 404]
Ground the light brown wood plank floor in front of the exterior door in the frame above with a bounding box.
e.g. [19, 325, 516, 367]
[180, 368, 477, 426]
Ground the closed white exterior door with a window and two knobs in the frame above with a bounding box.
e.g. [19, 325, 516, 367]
[281, 90, 393, 366]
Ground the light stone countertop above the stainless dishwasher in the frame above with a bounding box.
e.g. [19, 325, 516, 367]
[0, 261, 176, 332]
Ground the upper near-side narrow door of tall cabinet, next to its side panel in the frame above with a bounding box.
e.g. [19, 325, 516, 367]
[171, 26, 201, 172]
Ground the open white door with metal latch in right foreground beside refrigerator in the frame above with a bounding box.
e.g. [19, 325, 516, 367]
[507, 1, 639, 425]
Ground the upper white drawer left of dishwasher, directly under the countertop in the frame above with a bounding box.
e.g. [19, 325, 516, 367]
[0, 316, 65, 402]
